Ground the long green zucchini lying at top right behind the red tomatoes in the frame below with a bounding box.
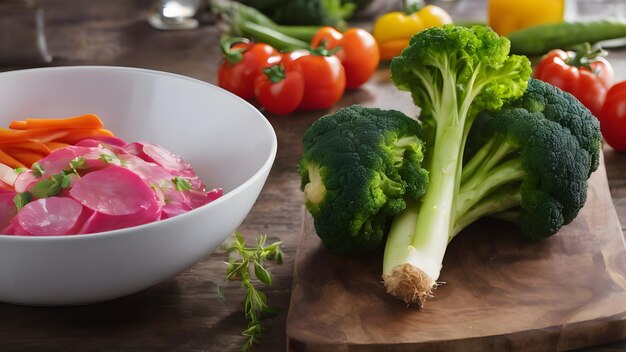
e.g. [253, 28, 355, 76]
[507, 20, 626, 55]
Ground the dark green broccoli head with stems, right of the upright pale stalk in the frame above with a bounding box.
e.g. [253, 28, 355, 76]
[453, 80, 602, 240]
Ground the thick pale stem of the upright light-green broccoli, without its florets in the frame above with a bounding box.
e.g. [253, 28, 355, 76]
[383, 56, 477, 303]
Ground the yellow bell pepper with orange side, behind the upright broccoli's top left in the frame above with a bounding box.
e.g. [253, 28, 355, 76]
[372, 5, 452, 60]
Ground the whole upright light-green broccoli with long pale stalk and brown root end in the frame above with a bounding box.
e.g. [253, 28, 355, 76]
[383, 25, 531, 304]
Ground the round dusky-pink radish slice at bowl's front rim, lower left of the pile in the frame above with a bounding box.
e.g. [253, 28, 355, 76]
[16, 197, 83, 236]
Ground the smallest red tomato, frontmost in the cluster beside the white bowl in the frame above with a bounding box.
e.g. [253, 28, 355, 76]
[254, 65, 304, 115]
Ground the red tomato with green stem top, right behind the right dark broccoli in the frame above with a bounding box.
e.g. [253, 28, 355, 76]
[534, 49, 613, 116]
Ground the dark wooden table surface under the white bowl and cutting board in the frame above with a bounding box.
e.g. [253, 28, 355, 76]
[0, 0, 626, 352]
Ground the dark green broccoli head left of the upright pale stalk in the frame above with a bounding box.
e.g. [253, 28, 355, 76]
[298, 105, 428, 254]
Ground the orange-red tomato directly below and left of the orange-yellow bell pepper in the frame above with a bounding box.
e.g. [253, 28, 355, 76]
[311, 27, 380, 88]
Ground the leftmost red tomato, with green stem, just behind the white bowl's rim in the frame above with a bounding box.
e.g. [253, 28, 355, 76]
[217, 43, 281, 99]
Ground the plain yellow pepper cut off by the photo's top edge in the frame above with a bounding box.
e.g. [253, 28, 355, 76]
[488, 0, 564, 35]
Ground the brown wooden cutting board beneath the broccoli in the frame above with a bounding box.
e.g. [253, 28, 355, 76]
[287, 155, 626, 352]
